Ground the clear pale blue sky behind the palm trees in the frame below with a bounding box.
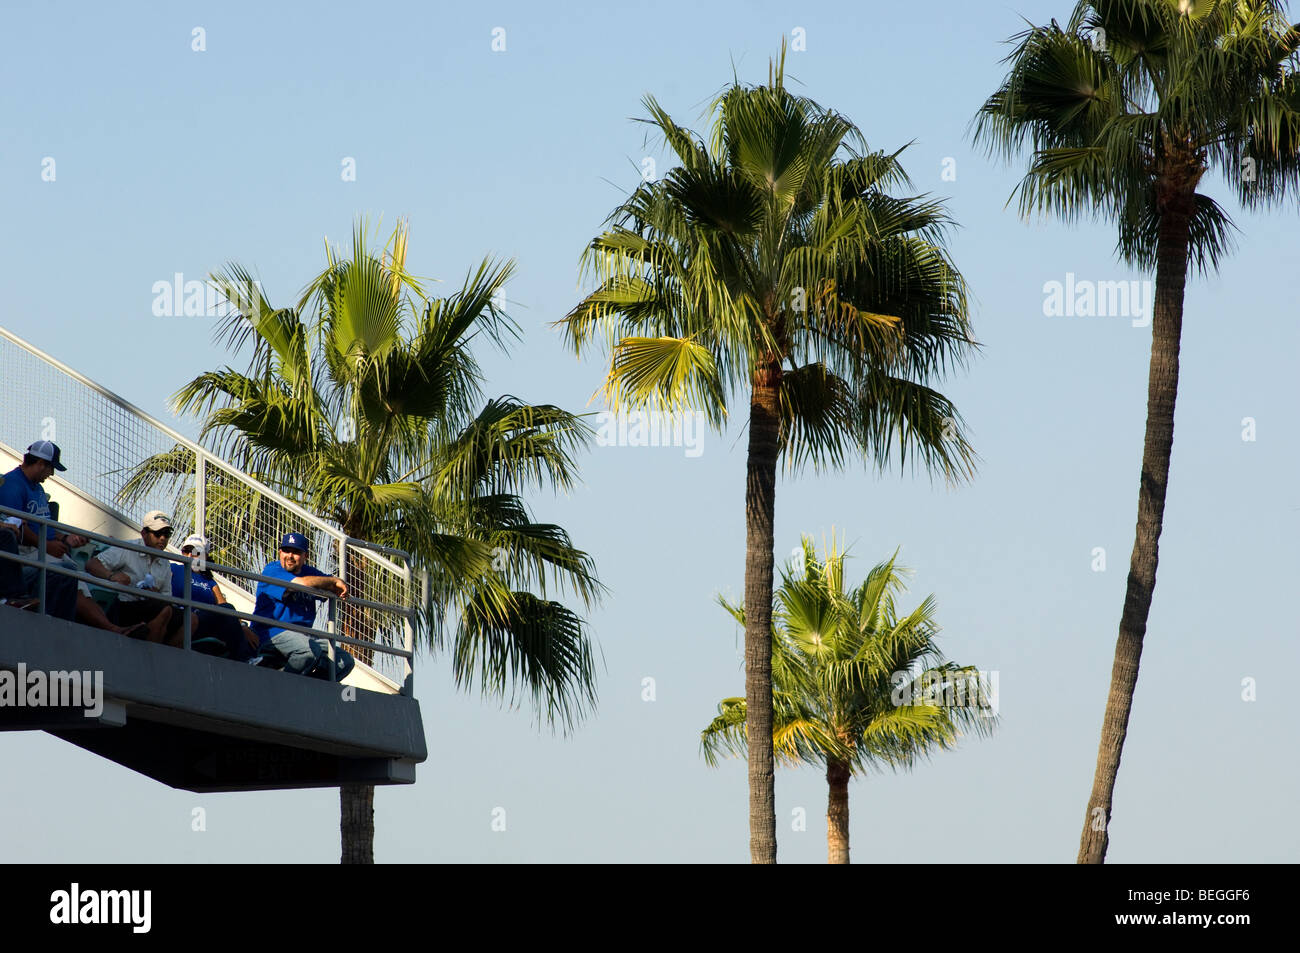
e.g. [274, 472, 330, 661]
[0, 0, 1300, 862]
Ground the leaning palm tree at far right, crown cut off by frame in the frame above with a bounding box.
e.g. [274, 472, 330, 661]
[975, 0, 1300, 863]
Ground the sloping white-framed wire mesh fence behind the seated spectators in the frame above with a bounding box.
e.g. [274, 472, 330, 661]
[0, 328, 420, 690]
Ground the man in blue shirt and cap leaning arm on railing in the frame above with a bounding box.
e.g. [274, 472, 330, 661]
[251, 533, 356, 681]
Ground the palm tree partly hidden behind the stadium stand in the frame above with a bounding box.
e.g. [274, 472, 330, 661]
[138, 224, 602, 862]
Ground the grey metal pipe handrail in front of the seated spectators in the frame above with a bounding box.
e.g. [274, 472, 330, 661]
[0, 506, 415, 692]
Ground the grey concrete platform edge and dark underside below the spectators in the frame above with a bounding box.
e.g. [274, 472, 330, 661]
[0, 606, 428, 792]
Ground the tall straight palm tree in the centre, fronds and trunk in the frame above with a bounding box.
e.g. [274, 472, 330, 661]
[558, 49, 972, 863]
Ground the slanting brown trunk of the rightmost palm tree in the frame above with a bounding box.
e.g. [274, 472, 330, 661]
[1078, 189, 1196, 863]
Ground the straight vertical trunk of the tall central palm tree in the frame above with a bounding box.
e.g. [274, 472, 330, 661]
[745, 361, 781, 863]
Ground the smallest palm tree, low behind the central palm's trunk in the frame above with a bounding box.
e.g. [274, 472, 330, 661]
[701, 537, 997, 863]
